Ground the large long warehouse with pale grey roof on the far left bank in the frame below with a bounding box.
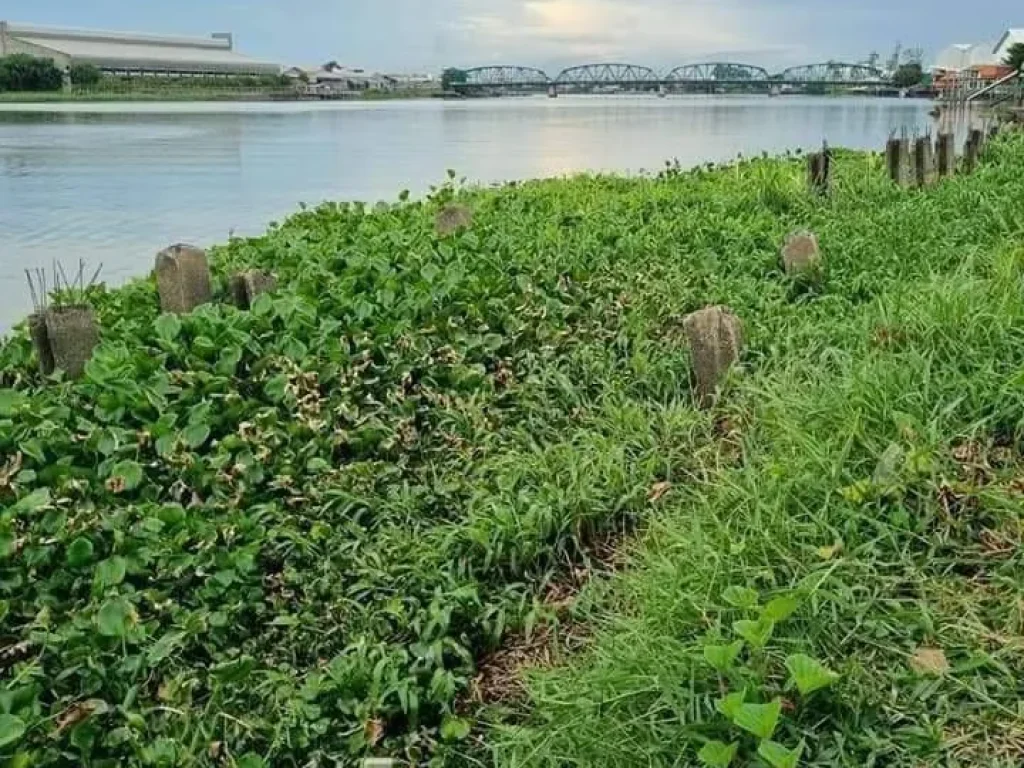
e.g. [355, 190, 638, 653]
[0, 22, 281, 76]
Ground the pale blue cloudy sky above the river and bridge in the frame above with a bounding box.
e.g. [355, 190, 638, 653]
[8, 0, 1024, 71]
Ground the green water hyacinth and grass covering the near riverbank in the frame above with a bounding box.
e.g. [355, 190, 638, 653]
[0, 132, 1024, 768]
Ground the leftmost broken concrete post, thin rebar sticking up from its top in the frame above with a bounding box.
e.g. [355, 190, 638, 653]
[29, 306, 99, 379]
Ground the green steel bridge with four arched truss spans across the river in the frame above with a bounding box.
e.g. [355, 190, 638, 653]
[452, 61, 890, 92]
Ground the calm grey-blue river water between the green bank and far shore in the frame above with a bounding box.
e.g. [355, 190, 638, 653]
[0, 96, 931, 329]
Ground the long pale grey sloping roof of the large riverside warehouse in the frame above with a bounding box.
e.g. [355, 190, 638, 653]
[7, 24, 279, 73]
